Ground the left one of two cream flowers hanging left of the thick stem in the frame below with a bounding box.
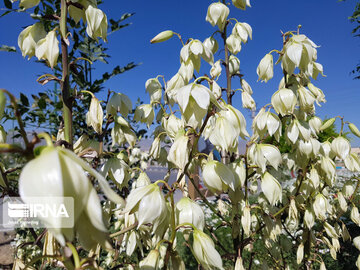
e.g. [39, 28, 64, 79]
[18, 23, 46, 59]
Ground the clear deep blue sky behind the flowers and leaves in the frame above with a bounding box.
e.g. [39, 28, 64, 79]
[0, 0, 360, 146]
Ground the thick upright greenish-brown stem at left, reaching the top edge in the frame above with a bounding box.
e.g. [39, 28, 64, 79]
[60, 0, 73, 148]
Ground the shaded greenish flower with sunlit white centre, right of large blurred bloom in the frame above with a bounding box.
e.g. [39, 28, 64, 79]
[101, 157, 130, 188]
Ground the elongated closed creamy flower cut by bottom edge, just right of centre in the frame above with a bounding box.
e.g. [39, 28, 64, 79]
[192, 229, 223, 270]
